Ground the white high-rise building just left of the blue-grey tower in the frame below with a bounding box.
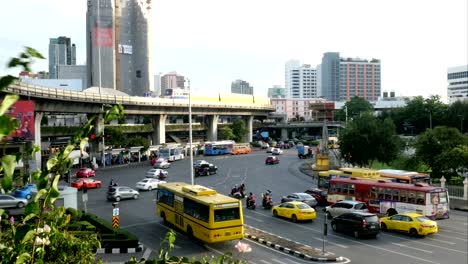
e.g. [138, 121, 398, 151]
[285, 60, 317, 99]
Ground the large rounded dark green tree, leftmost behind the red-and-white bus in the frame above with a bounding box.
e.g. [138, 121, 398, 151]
[340, 112, 401, 167]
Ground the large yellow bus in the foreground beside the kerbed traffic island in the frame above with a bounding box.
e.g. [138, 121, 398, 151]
[156, 182, 244, 243]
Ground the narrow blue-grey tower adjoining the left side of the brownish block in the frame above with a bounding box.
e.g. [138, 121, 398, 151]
[320, 52, 340, 101]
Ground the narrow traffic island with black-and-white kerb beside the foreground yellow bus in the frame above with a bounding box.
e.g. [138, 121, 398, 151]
[244, 225, 346, 262]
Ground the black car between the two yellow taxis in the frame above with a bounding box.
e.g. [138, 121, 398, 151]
[331, 212, 380, 238]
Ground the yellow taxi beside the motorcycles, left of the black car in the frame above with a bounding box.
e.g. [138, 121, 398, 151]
[271, 201, 317, 223]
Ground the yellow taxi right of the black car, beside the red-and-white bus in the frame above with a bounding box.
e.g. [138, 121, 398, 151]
[380, 213, 439, 236]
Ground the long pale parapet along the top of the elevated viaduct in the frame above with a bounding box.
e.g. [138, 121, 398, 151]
[5, 82, 274, 110]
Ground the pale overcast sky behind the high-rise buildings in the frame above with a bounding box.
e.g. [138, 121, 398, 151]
[0, 0, 468, 101]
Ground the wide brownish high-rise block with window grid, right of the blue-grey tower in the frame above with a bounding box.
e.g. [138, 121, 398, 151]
[337, 58, 381, 101]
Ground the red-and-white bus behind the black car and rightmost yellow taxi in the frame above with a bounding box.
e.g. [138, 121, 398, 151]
[327, 178, 450, 219]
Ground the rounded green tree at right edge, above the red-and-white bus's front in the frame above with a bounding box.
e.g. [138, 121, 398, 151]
[415, 126, 468, 179]
